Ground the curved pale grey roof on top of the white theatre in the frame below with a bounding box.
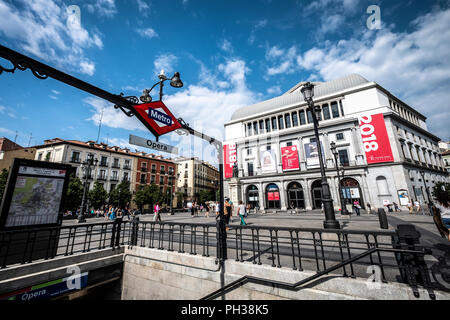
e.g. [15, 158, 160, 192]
[231, 74, 370, 121]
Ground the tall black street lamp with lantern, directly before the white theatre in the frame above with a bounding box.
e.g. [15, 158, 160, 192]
[301, 82, 340, 229]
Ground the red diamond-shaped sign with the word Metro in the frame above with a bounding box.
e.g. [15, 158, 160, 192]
[133, 101, 181, 137]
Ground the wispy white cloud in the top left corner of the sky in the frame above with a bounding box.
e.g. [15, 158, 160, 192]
[0, 0, 103, 74]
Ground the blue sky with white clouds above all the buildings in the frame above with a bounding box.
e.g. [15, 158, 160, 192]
[0, 0, 450, 165]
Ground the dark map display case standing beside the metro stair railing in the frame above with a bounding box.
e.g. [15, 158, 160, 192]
[0, 158, 73, 264]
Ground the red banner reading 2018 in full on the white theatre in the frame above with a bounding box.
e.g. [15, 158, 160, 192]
[359, 113, 394, 164]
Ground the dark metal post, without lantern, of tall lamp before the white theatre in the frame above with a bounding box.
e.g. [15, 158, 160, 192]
[308, 101, 340, 229]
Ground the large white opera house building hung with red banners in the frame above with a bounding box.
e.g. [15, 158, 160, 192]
[224, 74, 448, 211]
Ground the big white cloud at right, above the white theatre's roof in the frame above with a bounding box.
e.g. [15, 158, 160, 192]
[297, 9, 450, 139]
